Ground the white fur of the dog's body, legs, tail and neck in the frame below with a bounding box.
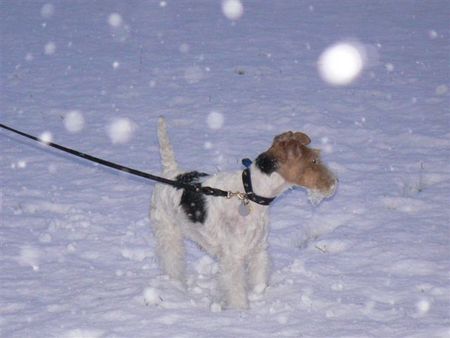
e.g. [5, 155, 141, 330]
[151, 118, 291, 309]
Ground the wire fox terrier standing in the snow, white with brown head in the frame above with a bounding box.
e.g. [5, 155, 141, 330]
[151, 118, 337, 309]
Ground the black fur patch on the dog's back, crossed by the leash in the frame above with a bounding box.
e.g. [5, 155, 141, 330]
[176, 171, 208, 223]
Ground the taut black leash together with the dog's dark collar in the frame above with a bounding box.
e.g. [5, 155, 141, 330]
[0, 123, 274, 205]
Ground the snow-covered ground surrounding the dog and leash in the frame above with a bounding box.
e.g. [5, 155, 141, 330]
[0, 0, 450, 338]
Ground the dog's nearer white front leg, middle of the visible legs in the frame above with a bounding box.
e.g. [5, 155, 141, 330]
[220, 255, 248, 309]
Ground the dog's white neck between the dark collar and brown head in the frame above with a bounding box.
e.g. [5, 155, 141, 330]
[250, 163, 292, 198]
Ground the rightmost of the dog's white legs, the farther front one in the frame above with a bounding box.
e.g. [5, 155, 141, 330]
[248, 248, 270, 293]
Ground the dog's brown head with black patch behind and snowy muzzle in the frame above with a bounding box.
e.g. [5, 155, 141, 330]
[256, 131, 337, 204]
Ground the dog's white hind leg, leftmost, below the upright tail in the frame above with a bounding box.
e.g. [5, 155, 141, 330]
[152, 210, 185, 283]
